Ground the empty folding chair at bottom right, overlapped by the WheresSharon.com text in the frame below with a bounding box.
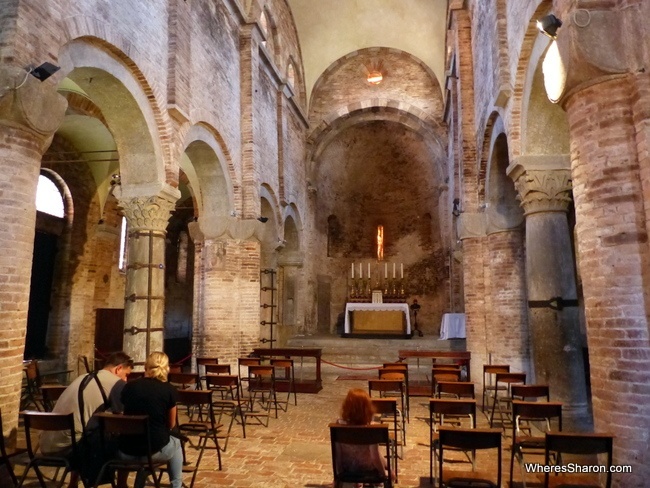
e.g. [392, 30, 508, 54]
[544, 432, 614, 488]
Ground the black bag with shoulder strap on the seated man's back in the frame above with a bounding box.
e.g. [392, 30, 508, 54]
[72, 371, 117, 486]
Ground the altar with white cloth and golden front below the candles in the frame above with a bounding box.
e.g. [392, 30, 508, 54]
[343, 303, 411, 337]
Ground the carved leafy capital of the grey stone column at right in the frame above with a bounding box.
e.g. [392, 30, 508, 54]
[513, 169, 572, 215]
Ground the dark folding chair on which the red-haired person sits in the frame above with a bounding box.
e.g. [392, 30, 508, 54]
[329, 423, 393, 487]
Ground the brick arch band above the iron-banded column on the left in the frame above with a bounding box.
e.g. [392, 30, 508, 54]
[60, 15, 173, 187]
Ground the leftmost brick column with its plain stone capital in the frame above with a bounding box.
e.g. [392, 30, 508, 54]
[0, 66, 67, 439]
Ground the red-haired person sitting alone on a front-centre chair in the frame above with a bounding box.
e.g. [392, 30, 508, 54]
[334, 388, 387, 484]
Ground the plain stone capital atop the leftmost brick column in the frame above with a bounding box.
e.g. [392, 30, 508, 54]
[0, 66, 68, 146]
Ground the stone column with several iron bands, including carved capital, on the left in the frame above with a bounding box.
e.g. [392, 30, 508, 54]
[116, 188, 178, 364]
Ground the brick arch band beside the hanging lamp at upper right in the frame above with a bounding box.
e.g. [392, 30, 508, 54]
[508, 0, 553, 160]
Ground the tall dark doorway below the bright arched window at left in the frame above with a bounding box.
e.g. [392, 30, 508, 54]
[25, 231, 58, 359]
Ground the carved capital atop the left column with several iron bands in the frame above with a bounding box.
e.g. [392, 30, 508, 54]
[115, 187, 180, 232]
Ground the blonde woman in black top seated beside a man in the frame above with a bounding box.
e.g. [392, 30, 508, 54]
[119, 352, 183, 488]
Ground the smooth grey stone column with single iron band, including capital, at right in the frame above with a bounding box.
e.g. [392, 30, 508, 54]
[508, 156, 591, 430]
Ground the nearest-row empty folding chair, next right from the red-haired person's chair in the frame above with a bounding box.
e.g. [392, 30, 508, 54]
[438, 427, 501, 488]
